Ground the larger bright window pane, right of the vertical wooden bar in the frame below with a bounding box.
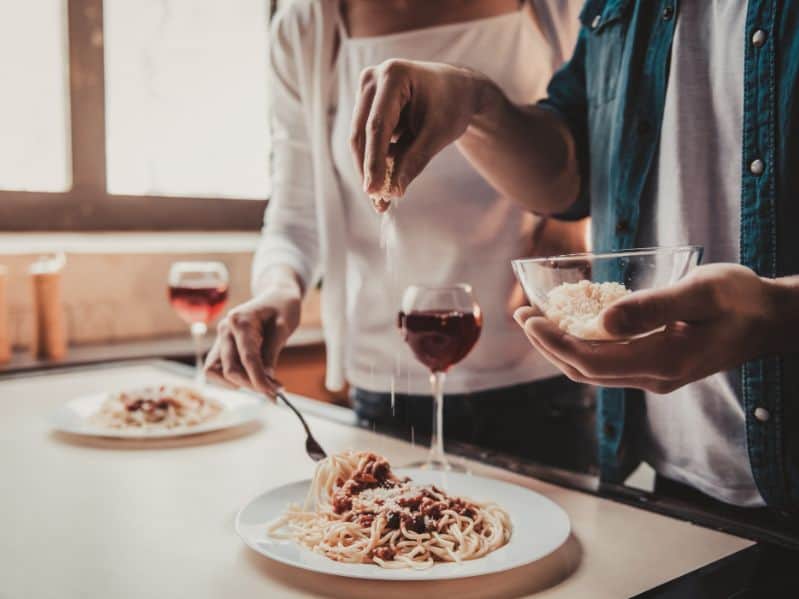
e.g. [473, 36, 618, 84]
[103, 0, 268, 198]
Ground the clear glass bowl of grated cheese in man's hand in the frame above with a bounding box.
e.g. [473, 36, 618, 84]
[512, 245, 703, 341]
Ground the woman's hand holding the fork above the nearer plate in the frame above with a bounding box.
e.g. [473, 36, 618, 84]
[205, 274, 302, 397]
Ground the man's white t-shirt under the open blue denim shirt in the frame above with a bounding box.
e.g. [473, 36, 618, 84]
[640, 0, 763, 506]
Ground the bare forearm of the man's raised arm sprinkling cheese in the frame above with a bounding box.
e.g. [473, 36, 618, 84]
[457, 79, 580, 215]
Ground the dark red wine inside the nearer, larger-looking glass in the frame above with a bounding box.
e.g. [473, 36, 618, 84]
[398, 310, 483, 372]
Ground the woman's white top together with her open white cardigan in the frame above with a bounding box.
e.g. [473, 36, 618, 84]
[253, 0, 580, 393]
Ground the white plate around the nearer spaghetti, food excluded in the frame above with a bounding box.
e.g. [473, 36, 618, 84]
[236, 468, 571, 580]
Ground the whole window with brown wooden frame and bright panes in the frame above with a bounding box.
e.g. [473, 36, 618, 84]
[0, 0, 275, 231]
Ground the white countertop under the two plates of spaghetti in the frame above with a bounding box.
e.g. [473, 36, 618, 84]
[0, 364, 751, 599]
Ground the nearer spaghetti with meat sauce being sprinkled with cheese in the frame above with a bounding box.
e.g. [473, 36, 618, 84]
[267, 452, 511, 569]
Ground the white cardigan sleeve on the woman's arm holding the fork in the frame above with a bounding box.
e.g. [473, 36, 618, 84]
[251, 10, 319, 292]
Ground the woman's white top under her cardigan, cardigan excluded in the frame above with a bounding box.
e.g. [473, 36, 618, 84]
[332, 8, 575, 394]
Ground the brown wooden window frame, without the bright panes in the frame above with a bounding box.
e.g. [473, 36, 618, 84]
[0, 0, 277, 232]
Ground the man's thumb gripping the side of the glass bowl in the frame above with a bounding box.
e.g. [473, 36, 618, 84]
[602, 279, 719, 337]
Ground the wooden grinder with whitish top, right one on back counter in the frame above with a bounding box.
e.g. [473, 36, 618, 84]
[30, 253, 67, 360]
